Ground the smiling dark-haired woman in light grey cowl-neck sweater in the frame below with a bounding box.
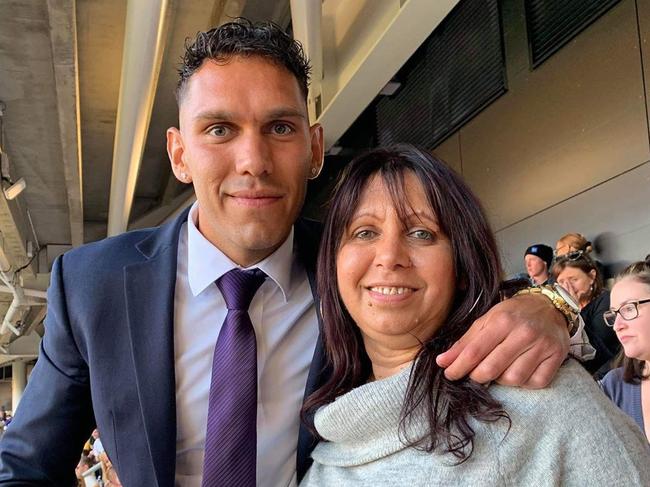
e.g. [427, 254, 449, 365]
[301, 146, 650, 486]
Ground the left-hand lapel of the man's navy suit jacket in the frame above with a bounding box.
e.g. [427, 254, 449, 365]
[124, 210, 189, 487]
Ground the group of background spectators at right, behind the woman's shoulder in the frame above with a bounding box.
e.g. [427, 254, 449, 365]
[511, 233, 650, 438]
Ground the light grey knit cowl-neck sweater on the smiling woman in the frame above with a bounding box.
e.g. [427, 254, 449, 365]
[300, 361, 650, 487]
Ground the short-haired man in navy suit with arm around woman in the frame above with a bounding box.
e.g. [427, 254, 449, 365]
[0, 19, 568, 487]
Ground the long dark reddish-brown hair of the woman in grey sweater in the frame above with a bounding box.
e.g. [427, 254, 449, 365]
[303, 145, 509, 461]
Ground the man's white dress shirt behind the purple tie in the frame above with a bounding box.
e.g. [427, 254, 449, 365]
[174, 203, 318, 487]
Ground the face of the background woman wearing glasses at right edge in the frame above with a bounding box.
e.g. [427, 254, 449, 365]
[610, 277, 650, 360]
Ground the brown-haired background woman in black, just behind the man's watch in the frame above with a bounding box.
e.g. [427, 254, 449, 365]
[553, 254, 620, 379]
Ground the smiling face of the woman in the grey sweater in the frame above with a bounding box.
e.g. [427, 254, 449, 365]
[336, 172, 456, 350]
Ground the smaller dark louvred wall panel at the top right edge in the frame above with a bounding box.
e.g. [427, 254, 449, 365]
[525, 0, 620, 67]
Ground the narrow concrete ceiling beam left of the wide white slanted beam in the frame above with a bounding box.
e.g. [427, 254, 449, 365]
[47, 0, 84, 247]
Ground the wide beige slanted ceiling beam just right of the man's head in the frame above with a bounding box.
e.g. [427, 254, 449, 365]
[317, 0, 459, 149]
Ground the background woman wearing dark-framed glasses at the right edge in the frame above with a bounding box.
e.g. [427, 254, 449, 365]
[601, 255, 650, 438]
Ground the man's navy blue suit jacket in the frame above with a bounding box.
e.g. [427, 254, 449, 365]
[0, 210, 325, 487]
